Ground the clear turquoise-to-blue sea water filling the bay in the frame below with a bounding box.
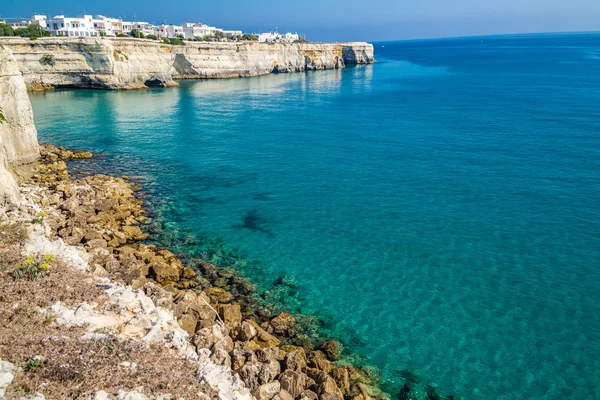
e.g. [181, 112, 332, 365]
[32, 34, 600, 399]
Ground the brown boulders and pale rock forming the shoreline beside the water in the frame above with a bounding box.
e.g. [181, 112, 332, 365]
[0, 146, 394, 400]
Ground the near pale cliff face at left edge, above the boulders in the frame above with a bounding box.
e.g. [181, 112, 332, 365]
[0, 44, 39, 203]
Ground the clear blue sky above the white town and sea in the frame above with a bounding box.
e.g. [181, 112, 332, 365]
[0, 0, 600, 41]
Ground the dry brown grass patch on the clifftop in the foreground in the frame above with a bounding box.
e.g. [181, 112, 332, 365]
[0, 262, 216, 399]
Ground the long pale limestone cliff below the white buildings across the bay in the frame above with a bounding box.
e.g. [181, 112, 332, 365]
[0, 38, 374, 89]
